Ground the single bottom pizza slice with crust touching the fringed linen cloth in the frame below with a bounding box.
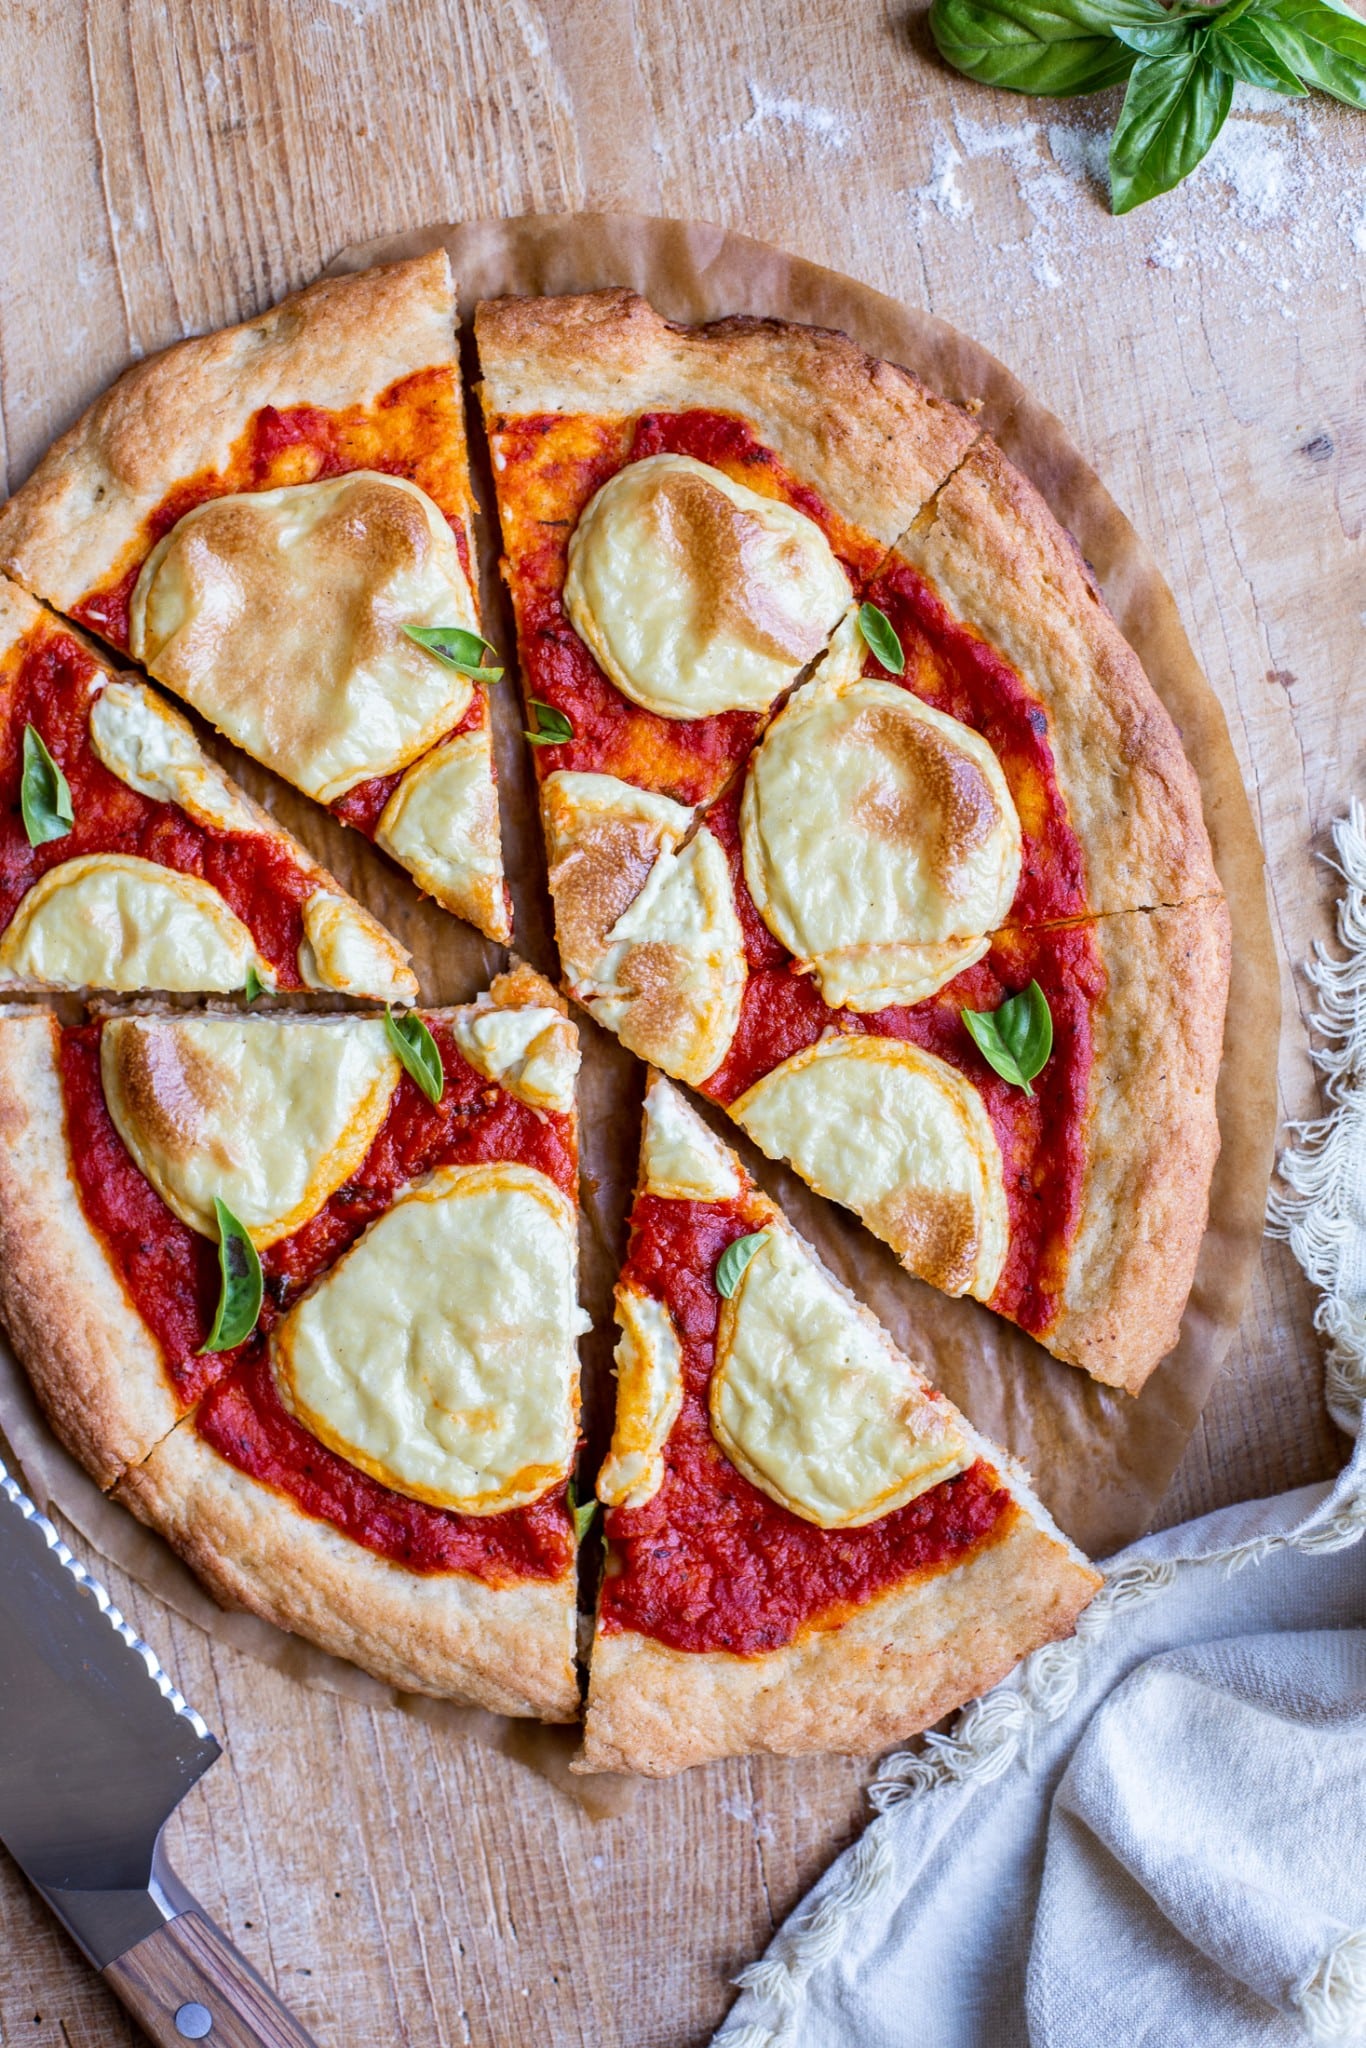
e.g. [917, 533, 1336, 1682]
[580, 1079, 1100, 1776]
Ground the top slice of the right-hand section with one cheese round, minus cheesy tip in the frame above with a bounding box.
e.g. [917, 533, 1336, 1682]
[475, 291, 975, 805]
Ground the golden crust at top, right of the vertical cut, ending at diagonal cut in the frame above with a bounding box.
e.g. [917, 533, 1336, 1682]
[475, 291, 977, 545]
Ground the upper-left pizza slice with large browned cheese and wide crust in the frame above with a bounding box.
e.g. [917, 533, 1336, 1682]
[0, 250, 510, 940]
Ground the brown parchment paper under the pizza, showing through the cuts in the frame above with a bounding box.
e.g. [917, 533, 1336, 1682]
[0, 213, 1280, 1812]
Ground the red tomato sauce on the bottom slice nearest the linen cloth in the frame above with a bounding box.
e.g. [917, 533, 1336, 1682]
[600, 1194, 1016, 1657]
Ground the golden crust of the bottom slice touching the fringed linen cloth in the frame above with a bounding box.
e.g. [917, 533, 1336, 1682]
[575, 1509, 1100, 1778]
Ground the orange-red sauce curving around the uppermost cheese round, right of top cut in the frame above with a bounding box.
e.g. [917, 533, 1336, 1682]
[492, 410, 883, 805]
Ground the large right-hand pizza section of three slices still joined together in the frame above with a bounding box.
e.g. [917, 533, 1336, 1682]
[475, 293, 1229, 1393]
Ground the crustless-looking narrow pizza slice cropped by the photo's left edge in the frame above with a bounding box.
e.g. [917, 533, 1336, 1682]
[0, 578, 418, 1004]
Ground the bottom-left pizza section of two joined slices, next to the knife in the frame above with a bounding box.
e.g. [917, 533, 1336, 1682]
[0, 969, 584, 1720]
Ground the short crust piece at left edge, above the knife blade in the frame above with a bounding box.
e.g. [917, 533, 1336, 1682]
[0, 1012, 180, 1487]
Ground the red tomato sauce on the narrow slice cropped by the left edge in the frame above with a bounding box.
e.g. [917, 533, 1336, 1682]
[0, 625, 317, 989]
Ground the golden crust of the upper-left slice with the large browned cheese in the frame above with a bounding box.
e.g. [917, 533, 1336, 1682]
[0, 250, 455, 608]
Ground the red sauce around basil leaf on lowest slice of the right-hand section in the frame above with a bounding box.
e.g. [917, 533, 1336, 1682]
[702, 791, 1106, 1335]
